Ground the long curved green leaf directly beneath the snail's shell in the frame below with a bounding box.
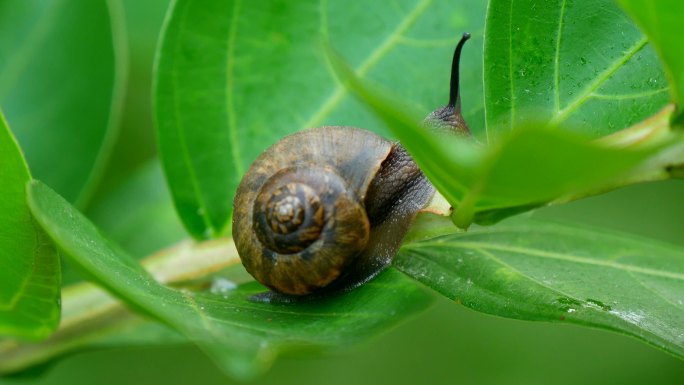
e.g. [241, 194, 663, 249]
[28, 182, 430, 378]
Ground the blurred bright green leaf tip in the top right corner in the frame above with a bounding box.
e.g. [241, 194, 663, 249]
[618, 0, 684, 124]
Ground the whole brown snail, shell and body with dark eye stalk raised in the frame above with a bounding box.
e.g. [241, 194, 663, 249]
[232, 33, 470, 301]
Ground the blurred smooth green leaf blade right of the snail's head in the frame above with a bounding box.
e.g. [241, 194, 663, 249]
[456, 128, 666, 224]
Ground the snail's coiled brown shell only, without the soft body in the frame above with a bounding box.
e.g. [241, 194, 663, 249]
[233, 127, 394, 295]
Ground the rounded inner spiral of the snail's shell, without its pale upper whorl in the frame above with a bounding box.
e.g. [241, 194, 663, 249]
[243, 167, 370, 294]
